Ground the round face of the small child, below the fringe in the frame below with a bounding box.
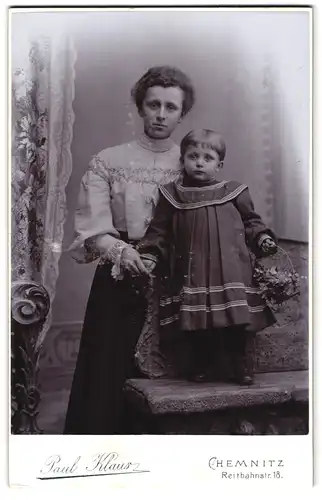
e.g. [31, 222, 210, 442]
[183, 145, 222, 181]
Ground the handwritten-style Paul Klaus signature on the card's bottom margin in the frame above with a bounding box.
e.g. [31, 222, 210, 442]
[37, 452, 150, 480]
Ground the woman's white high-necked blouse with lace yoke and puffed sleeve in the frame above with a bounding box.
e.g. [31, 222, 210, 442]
[70, 135, 181, 274]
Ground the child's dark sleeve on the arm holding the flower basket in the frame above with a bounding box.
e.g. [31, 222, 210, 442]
[235, 189, 277, 255]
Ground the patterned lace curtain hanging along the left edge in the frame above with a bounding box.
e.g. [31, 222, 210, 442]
[11, 30, 76, 344]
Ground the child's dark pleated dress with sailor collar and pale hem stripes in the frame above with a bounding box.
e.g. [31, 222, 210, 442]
[137, 179, 275, 332]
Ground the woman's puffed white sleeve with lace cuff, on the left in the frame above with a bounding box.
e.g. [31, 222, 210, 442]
[69, 155, 126, 263]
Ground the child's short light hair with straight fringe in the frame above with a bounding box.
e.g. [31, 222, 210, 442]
[180, 129, 226, 161]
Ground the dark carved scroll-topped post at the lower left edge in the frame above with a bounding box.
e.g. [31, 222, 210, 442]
[11, 281, 50, 434]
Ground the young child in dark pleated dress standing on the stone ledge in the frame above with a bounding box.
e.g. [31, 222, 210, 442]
[136, 130, 276, 385]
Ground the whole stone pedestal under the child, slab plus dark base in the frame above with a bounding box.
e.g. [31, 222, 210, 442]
[125, 371, 308, 435]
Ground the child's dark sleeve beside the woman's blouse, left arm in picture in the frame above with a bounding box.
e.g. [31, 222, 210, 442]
[136, 191, 174, 261]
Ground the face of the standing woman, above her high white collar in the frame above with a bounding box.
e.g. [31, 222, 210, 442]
[140, 86, 184, 139]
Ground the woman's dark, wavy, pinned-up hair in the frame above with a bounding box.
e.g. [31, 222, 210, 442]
[131, 66, 195, 116]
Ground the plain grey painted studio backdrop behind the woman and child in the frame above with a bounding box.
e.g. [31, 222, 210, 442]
[12, 10, 310, 430]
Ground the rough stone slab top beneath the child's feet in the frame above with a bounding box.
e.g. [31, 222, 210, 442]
[125, 370, 309, 415]
